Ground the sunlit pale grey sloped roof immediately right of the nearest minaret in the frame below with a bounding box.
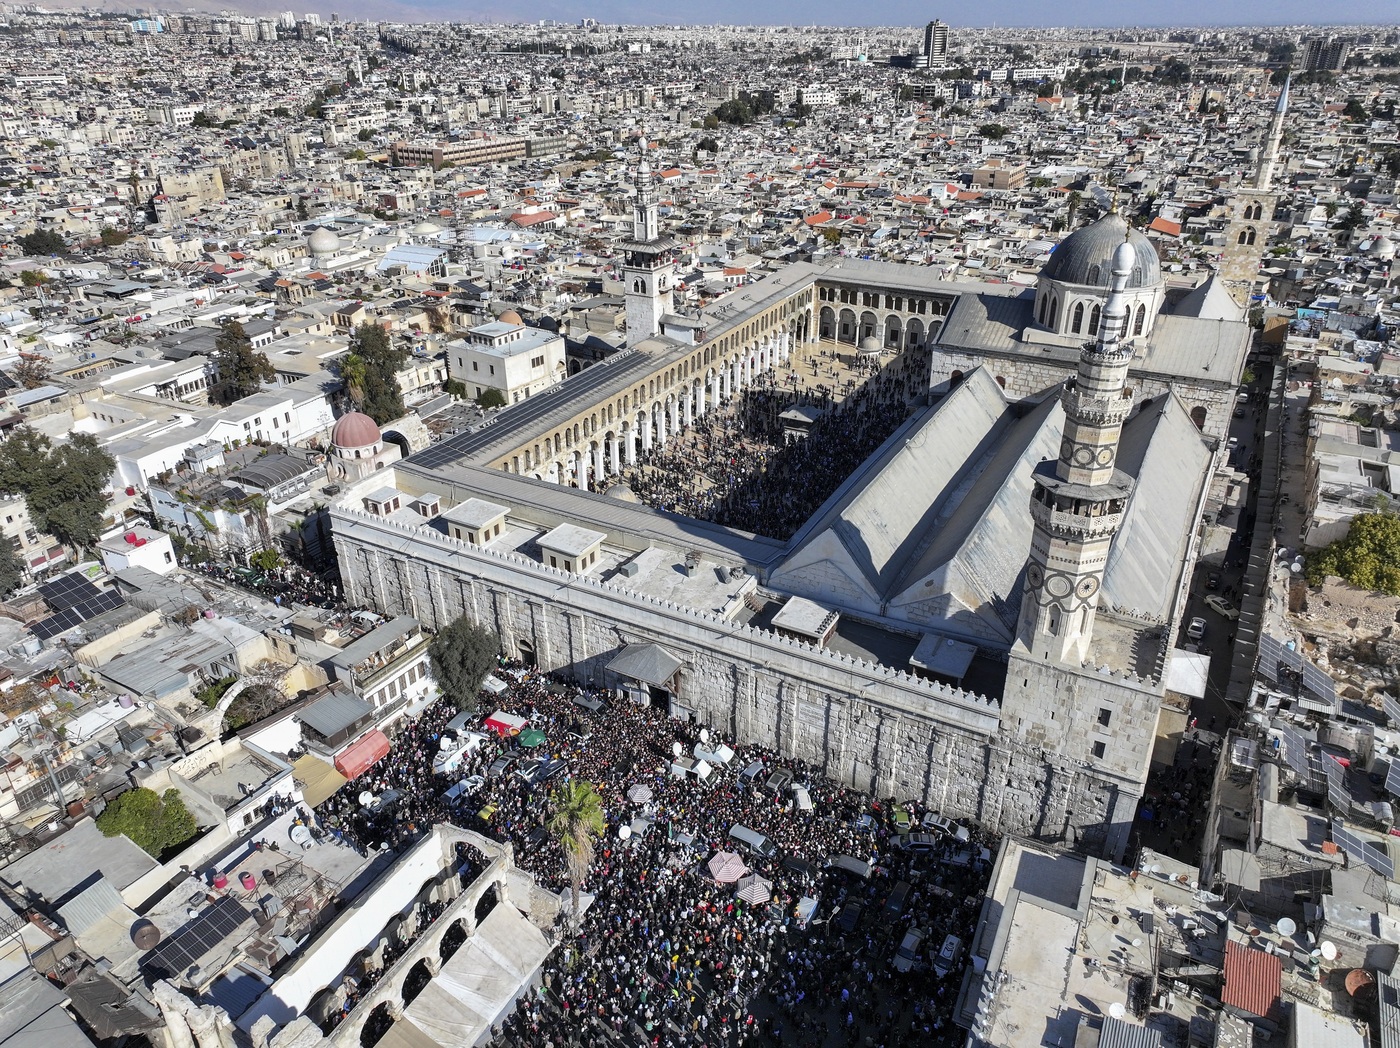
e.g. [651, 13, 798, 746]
[1103, 393, 1211, 621]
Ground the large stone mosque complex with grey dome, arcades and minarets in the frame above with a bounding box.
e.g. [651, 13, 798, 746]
[330, 153, 1250, 858]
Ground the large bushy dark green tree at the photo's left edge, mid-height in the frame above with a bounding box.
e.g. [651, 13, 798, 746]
[0, 425, 116, 550]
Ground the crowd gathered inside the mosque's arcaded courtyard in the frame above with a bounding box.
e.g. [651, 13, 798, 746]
[623, 341, 928, 539]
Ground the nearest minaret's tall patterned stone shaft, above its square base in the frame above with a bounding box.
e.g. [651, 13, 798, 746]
[1016, 239, 1135, 666]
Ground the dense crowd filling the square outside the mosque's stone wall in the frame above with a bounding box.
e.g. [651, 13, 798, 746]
[318, 666, 993, 1048]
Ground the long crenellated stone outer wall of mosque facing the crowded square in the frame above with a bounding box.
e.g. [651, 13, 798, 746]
[332, 507, 1151, 842]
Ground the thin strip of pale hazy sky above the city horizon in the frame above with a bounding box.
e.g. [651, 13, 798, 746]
[386, 0, 1400, 27]
